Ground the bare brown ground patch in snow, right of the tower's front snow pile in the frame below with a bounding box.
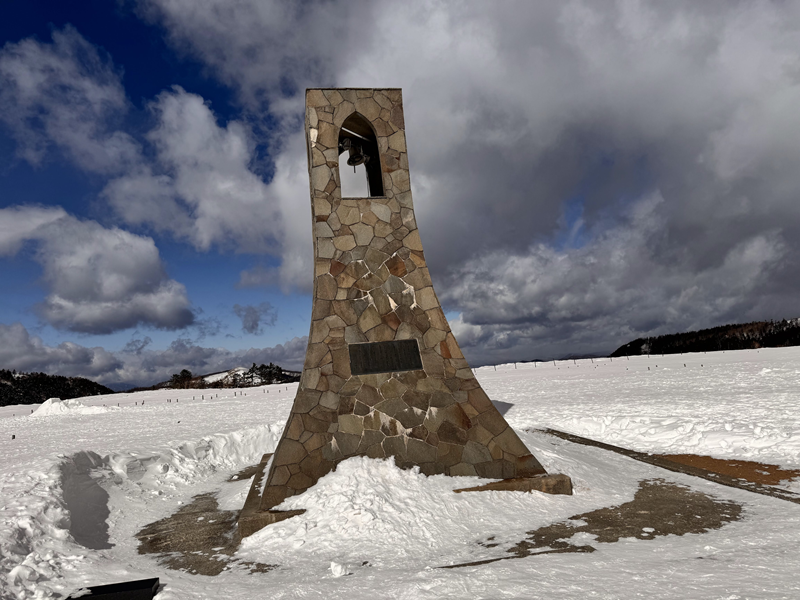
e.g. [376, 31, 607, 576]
[444, 479, 742, 568]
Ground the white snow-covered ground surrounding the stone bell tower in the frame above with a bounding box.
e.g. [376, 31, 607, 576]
[0, 348, 800, 600]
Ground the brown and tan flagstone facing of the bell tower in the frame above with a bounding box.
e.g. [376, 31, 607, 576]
[260, 89, 545, 511]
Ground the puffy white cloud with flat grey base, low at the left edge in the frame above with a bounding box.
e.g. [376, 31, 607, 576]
[0, 206, 194, 333]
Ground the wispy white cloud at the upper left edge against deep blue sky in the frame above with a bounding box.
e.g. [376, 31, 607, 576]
[0, 26, 139, 174]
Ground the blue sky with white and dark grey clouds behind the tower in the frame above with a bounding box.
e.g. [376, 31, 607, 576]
[0, 0, 800, 384]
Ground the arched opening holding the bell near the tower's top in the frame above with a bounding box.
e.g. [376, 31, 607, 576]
[339, 113, 383, 198]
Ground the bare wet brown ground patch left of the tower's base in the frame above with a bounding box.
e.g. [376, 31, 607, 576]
[136, 494, 274, 575]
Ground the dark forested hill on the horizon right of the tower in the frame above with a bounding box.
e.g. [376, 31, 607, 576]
[611, 319, 800, 357]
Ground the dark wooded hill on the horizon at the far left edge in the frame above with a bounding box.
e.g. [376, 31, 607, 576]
[0, 369, 114, 406]
